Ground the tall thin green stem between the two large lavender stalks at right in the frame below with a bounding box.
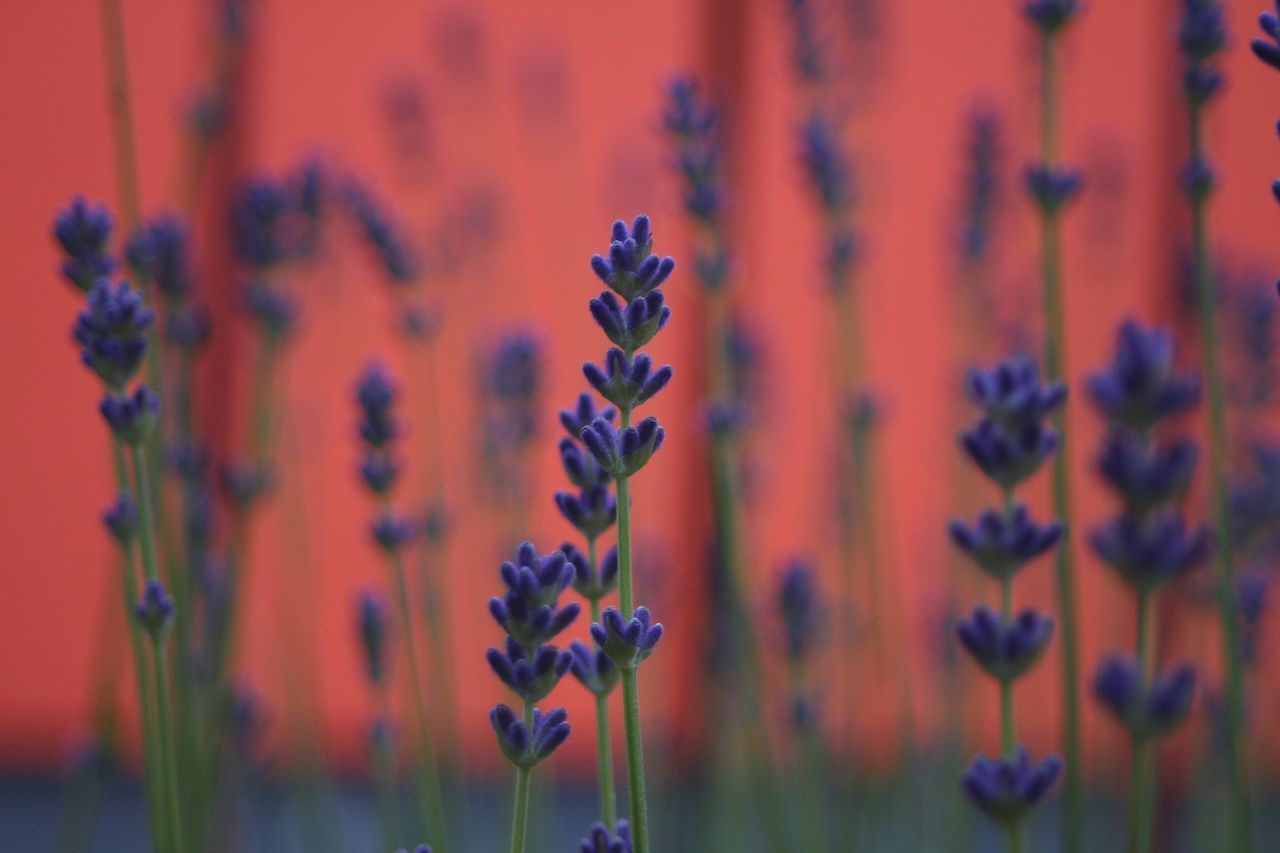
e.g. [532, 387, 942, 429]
[1041, 35, 1083, 853]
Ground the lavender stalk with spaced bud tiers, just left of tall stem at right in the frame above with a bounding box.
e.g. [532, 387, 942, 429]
[948, 356, 1066, 853]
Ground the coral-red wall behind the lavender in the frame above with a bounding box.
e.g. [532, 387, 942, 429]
[0, 0, 1280, 766]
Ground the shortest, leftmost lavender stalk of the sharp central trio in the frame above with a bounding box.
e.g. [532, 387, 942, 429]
[488, 542, 581, 853]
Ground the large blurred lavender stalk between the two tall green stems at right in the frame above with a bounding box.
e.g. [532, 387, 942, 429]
[1089, 320, 1208, 853]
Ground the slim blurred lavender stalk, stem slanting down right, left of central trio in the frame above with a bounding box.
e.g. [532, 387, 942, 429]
[356, 364, 449, 848]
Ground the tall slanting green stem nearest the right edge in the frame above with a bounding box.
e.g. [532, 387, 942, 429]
[1190, 94, 1252, 853]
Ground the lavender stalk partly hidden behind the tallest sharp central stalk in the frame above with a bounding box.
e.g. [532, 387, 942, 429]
[556, 393, 621, 826]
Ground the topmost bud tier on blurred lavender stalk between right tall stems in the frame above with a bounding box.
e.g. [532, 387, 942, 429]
[1088, 320, 1199, 432]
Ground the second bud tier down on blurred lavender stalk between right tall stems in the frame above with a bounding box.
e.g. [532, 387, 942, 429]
[1098, 429, 1199, 514]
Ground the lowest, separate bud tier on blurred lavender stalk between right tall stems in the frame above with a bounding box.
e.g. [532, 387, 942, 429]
[1093, 654, 1196, 739]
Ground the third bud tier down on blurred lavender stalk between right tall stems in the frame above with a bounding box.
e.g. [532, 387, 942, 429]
[1089, 510, 1210, 589]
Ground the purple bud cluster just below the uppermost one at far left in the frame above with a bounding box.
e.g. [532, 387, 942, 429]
[74, 279, 155, 388]
